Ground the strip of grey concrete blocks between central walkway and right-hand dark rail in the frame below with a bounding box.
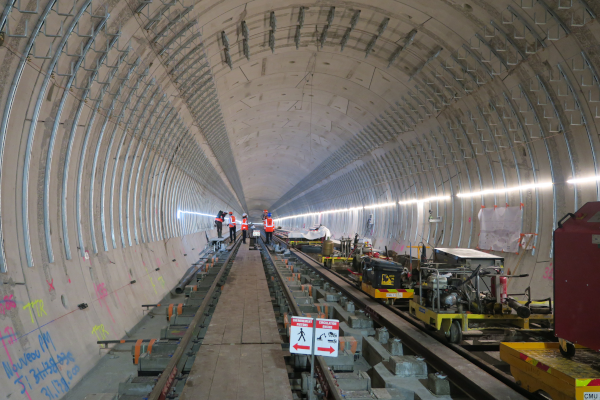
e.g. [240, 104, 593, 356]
[263, 238, 523, 400]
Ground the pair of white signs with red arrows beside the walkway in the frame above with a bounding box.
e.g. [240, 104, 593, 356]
[290, 317, 340, 357]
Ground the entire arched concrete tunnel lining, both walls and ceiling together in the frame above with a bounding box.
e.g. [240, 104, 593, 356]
[0, 0, 600, 400]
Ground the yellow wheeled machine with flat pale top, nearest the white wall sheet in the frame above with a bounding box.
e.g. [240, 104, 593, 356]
[409, 248, 553, 343]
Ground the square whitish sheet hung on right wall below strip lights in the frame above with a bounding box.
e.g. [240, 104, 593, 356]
[479, 207, 523, 253]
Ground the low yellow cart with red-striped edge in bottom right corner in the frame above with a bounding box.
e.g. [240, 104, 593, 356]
[500, 343, 600, 400]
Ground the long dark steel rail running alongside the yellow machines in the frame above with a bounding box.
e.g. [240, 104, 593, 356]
[274, 236, 545, 400]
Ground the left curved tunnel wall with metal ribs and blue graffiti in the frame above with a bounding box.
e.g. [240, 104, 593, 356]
[0, 0, 242, 399]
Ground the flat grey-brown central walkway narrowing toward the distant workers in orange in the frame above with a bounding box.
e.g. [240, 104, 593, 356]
[180, 245, 292, 400]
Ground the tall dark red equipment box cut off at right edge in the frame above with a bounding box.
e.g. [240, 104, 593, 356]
[554, 201, 600, 351]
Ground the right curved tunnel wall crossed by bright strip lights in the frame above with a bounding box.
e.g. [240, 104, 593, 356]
[274, 2, 600, 304]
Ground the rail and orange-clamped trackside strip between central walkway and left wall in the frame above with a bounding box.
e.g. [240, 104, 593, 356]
[98, 240, 241, 400]
